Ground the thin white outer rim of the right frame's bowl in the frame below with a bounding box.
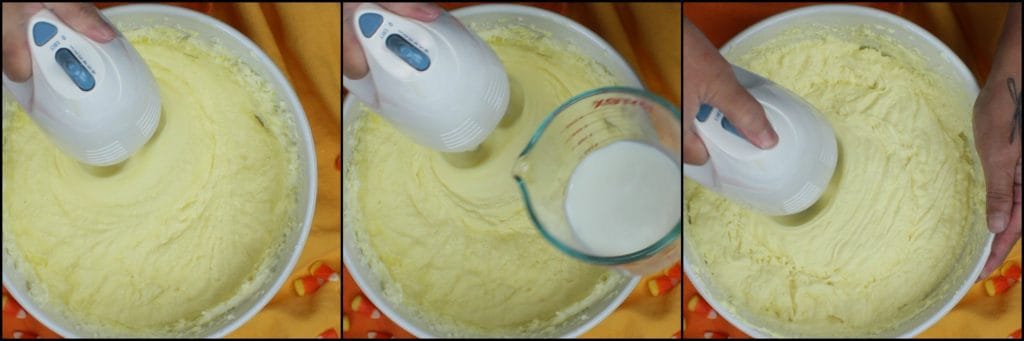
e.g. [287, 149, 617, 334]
[683, 4, 994, 338]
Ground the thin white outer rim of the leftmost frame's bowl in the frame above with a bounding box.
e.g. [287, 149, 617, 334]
[2, 4, 317, 338]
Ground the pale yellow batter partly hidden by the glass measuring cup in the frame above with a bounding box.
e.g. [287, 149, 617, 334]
[345, 23, 622, 336]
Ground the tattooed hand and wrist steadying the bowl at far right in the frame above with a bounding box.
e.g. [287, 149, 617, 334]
[974, 3, 1022, 281]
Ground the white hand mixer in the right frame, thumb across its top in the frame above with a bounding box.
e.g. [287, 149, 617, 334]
[683, 66, 839, 216]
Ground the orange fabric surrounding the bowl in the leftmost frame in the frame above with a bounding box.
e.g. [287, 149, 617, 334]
[3, 2, 341, 338]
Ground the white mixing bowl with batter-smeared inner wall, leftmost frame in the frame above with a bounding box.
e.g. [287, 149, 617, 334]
[3, 5, 316, 338]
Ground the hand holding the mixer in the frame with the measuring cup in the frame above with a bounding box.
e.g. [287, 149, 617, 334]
[341, 2, 441, 79]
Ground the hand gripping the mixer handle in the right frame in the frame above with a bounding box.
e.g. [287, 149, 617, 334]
[683, 16, 778, 165]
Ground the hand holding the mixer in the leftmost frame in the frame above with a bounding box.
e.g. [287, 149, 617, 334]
[3, 2, 114, 82]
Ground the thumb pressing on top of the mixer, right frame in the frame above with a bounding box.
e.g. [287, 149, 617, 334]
[707, 68, 778, 150]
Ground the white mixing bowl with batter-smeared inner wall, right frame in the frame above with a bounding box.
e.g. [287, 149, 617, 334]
[683, 5, 993, 338]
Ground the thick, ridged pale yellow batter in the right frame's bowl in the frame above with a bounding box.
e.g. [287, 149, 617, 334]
[684, 29, 984, 336]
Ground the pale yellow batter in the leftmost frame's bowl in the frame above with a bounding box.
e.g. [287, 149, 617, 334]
[3, 28, 296, 335]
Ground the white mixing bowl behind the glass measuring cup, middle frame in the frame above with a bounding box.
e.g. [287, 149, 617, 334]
[342, 5, 643, 338]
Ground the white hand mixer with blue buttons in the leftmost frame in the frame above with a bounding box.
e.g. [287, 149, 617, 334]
[3, 9, 161, 166]
